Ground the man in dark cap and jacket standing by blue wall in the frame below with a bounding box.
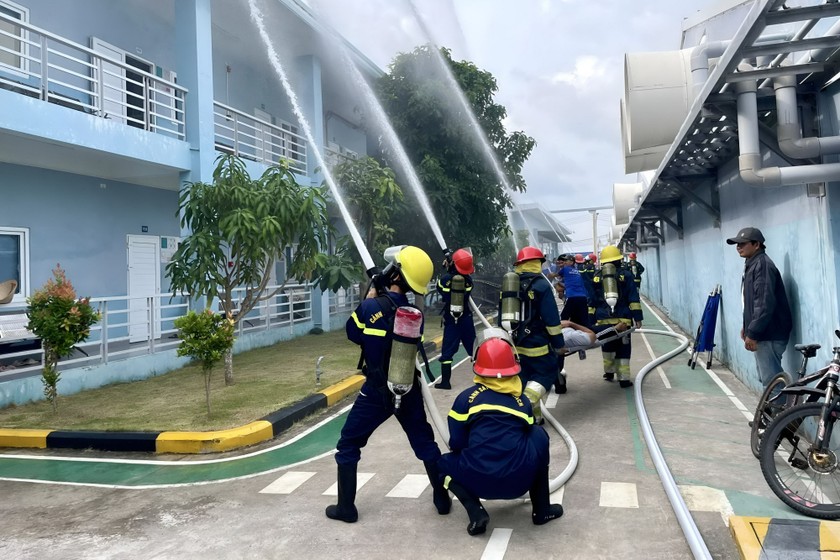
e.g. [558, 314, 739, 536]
[726, 227, 793, 387]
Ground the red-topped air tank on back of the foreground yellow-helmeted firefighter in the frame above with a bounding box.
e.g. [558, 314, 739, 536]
[388, 306, 423, 410]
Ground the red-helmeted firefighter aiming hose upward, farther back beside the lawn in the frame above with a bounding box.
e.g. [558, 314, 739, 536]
[435, 249, 475, 389]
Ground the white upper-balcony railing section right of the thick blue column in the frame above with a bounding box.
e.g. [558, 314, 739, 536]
[213, 102, 306, 175]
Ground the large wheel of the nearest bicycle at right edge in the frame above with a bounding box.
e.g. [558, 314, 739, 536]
[760, 403, 840, 519]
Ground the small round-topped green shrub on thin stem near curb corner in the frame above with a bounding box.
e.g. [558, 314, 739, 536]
[175, 309, 233, 416]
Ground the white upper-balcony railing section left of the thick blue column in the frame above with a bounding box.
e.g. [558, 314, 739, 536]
[0, 12, 187, 140]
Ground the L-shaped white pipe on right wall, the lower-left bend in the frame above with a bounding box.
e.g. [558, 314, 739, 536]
[735, 70, 840, 187]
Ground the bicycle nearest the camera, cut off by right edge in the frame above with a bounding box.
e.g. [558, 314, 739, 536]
[759, 330, 840, 519]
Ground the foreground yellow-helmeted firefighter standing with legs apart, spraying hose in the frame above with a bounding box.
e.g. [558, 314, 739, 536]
[326, 245, 452, 523]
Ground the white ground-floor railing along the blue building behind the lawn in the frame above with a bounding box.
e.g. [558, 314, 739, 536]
[0, 284, 359, 381]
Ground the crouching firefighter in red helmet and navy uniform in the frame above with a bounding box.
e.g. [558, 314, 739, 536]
[438, 327, 563, 535]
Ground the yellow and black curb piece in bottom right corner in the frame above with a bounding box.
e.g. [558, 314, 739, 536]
[729, 515, 840, 560]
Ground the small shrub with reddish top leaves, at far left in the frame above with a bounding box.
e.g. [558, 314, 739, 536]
[26, 265, 100, 411]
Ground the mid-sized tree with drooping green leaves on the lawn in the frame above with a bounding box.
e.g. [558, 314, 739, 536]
[166, 155, 331, 385]
